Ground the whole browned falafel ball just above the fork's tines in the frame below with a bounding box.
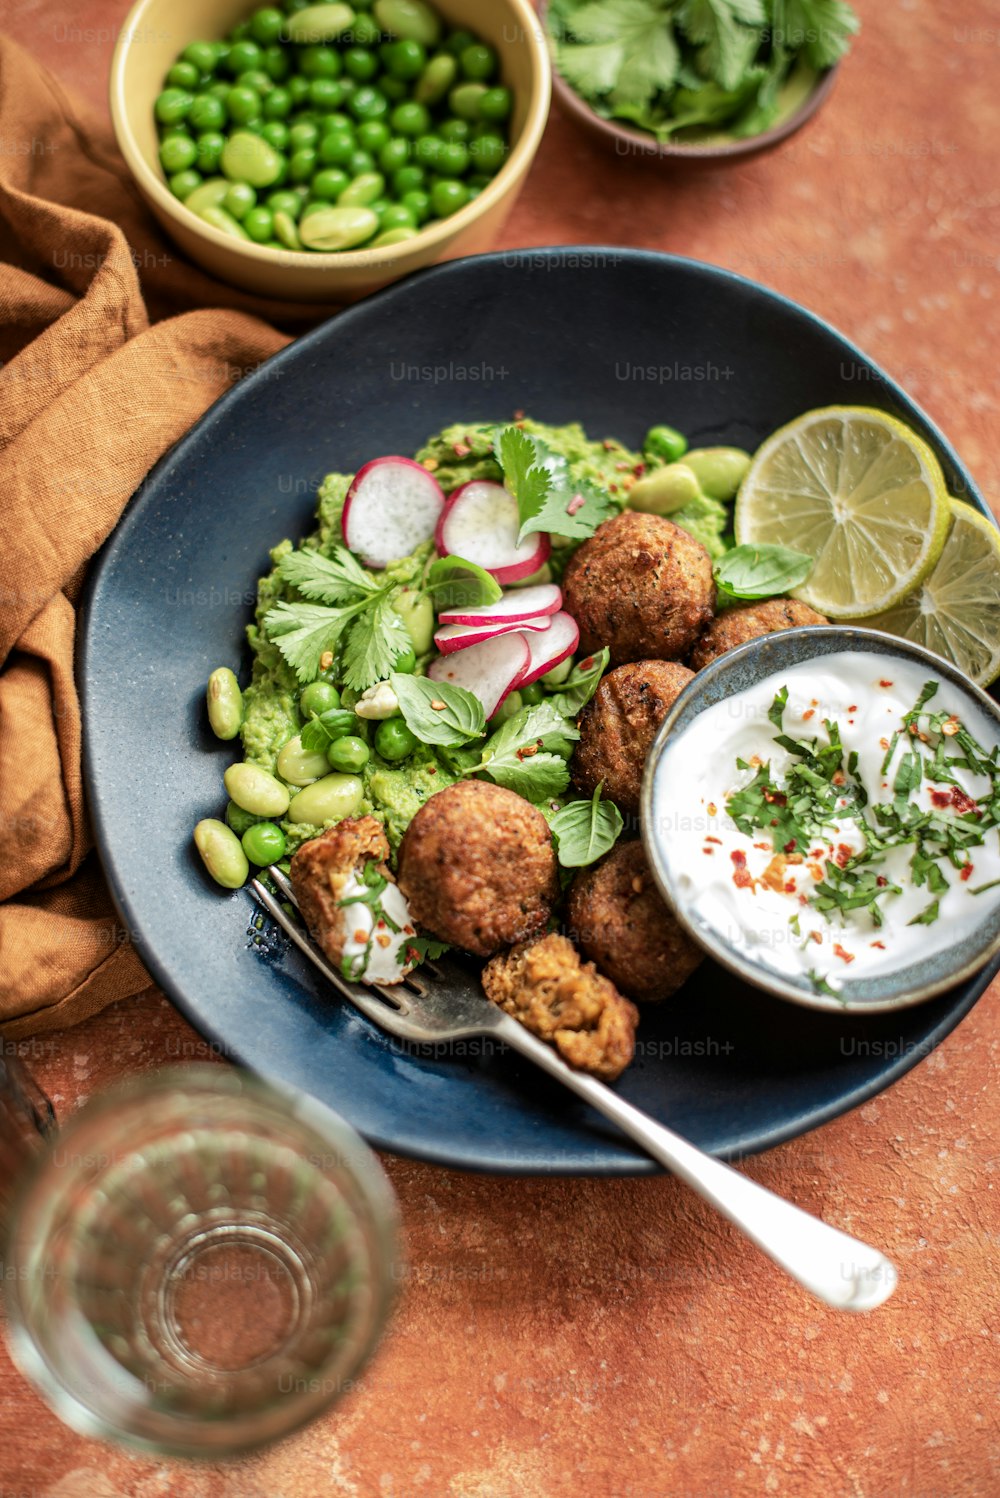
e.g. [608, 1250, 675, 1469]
[400, 780, 560, 957]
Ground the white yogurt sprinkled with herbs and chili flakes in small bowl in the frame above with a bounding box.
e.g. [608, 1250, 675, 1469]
[653, 652, 1000, 989]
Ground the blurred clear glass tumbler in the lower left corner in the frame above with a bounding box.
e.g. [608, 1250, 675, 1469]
[6, 1065, 400, 1459]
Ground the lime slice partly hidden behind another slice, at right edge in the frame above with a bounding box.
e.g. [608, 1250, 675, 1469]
[864, 499, 1000, 686]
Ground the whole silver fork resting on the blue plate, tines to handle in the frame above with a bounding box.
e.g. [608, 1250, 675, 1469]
[250, 869, 897, 1311]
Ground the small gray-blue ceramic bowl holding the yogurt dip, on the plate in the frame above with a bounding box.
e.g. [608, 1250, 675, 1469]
[641, 625, 1000, 1014]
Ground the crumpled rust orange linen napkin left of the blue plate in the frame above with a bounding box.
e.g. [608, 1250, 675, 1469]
[0, 37, 327, 1038]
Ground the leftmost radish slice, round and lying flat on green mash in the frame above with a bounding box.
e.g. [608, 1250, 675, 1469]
[341, 457, 445, 568]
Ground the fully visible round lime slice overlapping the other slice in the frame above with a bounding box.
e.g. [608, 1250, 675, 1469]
[735, 406, 951, 619]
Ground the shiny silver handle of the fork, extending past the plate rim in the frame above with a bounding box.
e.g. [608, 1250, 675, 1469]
[501, 1016, 897, 1311]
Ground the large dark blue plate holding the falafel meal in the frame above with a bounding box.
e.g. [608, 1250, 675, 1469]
[78, 247, 997, 1174]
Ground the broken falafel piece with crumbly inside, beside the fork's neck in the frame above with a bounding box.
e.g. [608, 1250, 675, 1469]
[482, 933, 639, 1082]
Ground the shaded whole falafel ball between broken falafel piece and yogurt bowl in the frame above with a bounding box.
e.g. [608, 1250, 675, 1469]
[566, 840, 704, 1004]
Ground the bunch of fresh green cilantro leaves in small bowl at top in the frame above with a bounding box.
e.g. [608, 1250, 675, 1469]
[548, 0, 859, 142]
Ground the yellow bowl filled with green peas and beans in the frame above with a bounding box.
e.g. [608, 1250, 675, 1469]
[111, 0, 549, 301]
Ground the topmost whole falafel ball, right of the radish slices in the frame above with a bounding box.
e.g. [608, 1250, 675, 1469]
[563, 509, 716, 665]
